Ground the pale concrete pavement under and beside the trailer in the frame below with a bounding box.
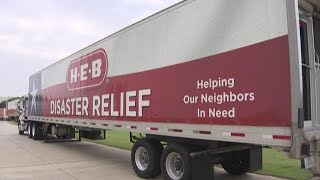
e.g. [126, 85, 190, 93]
[0, 121, 279, 180]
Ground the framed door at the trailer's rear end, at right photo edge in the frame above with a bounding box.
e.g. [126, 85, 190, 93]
[299, 10, 319, 127]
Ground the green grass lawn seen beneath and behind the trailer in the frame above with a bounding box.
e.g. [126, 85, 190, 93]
[80, 131, 311, 180]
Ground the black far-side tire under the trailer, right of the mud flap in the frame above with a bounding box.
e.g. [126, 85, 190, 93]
[221, 150, 250, 175]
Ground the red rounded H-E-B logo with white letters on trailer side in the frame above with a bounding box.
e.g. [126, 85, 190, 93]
[67, 49, 108, 90]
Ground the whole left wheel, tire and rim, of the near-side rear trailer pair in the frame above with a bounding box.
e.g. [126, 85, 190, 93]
[131, 139, 163, 179]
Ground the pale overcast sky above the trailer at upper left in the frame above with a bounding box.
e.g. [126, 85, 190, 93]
[0, 0, 180, 96]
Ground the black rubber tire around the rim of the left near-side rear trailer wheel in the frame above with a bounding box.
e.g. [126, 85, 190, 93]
[131, 139, 163, 179]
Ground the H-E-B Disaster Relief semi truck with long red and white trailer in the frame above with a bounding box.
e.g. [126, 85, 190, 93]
[19, 0, 320, 179]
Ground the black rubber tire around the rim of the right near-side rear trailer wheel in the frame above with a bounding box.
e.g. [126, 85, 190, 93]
[161, 144, 191, 180]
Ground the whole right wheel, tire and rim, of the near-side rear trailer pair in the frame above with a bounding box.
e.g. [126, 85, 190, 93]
[161, 144, 191, 180]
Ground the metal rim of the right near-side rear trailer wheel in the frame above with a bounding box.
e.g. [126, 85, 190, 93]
[166, 152, 184, 180]
